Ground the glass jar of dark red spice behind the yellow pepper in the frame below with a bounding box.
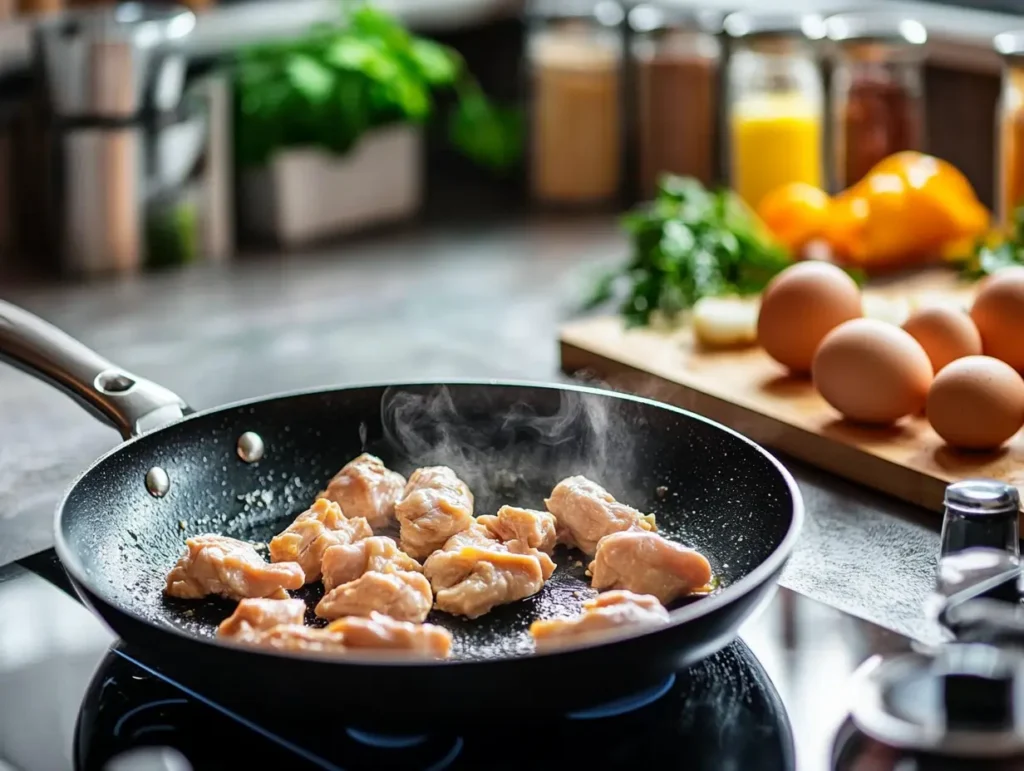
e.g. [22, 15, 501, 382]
[825, 14, 928, 189]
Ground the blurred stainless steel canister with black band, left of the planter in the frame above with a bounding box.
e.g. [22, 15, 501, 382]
[35, 2, 216, 274]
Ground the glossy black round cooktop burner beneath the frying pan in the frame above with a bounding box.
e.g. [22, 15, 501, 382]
[75, 642, 796, 771]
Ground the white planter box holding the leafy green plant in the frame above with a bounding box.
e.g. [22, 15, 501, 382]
[240, 126, 423, 247]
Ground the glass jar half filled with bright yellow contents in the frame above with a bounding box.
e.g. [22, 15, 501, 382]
[724, 13, 825, 208]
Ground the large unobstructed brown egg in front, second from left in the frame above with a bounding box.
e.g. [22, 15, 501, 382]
[812, 318, 932, 425]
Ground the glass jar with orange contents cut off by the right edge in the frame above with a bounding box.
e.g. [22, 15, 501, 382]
[995, 31, 1024, 228]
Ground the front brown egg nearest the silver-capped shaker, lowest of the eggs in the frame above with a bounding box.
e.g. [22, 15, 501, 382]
[927, 356, 1024, 449]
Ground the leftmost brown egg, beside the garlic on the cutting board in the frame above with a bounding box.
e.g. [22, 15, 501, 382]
[758, 261, 862, 374]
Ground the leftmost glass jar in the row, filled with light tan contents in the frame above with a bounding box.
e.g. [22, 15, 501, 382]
[527, 0, 626, 205]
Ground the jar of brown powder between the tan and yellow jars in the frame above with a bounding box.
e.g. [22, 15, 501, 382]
[629, 3, 722, 197]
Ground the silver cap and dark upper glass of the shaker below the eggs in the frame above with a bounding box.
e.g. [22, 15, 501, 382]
[939, 479, 1021, 559]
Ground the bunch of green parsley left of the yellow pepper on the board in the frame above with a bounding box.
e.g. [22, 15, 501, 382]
[588, 176, 791, 326]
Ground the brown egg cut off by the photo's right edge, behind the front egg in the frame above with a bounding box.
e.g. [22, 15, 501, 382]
[971, 267, 1024, 371]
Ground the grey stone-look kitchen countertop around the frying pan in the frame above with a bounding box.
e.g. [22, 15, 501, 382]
[0, 216, 940, 640]
